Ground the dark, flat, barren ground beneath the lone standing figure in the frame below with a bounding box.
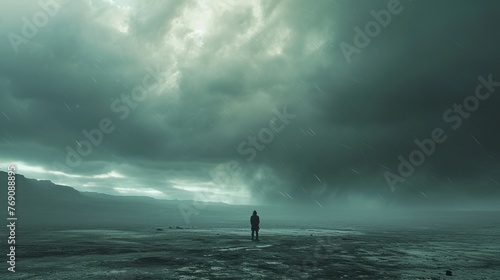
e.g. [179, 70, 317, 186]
[2, 220, 500, 279]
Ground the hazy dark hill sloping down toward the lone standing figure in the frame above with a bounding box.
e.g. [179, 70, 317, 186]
[0, 171, 256, 228]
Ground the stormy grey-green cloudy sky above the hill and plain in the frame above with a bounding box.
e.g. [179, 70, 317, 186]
[0, 0, 500, 207]
